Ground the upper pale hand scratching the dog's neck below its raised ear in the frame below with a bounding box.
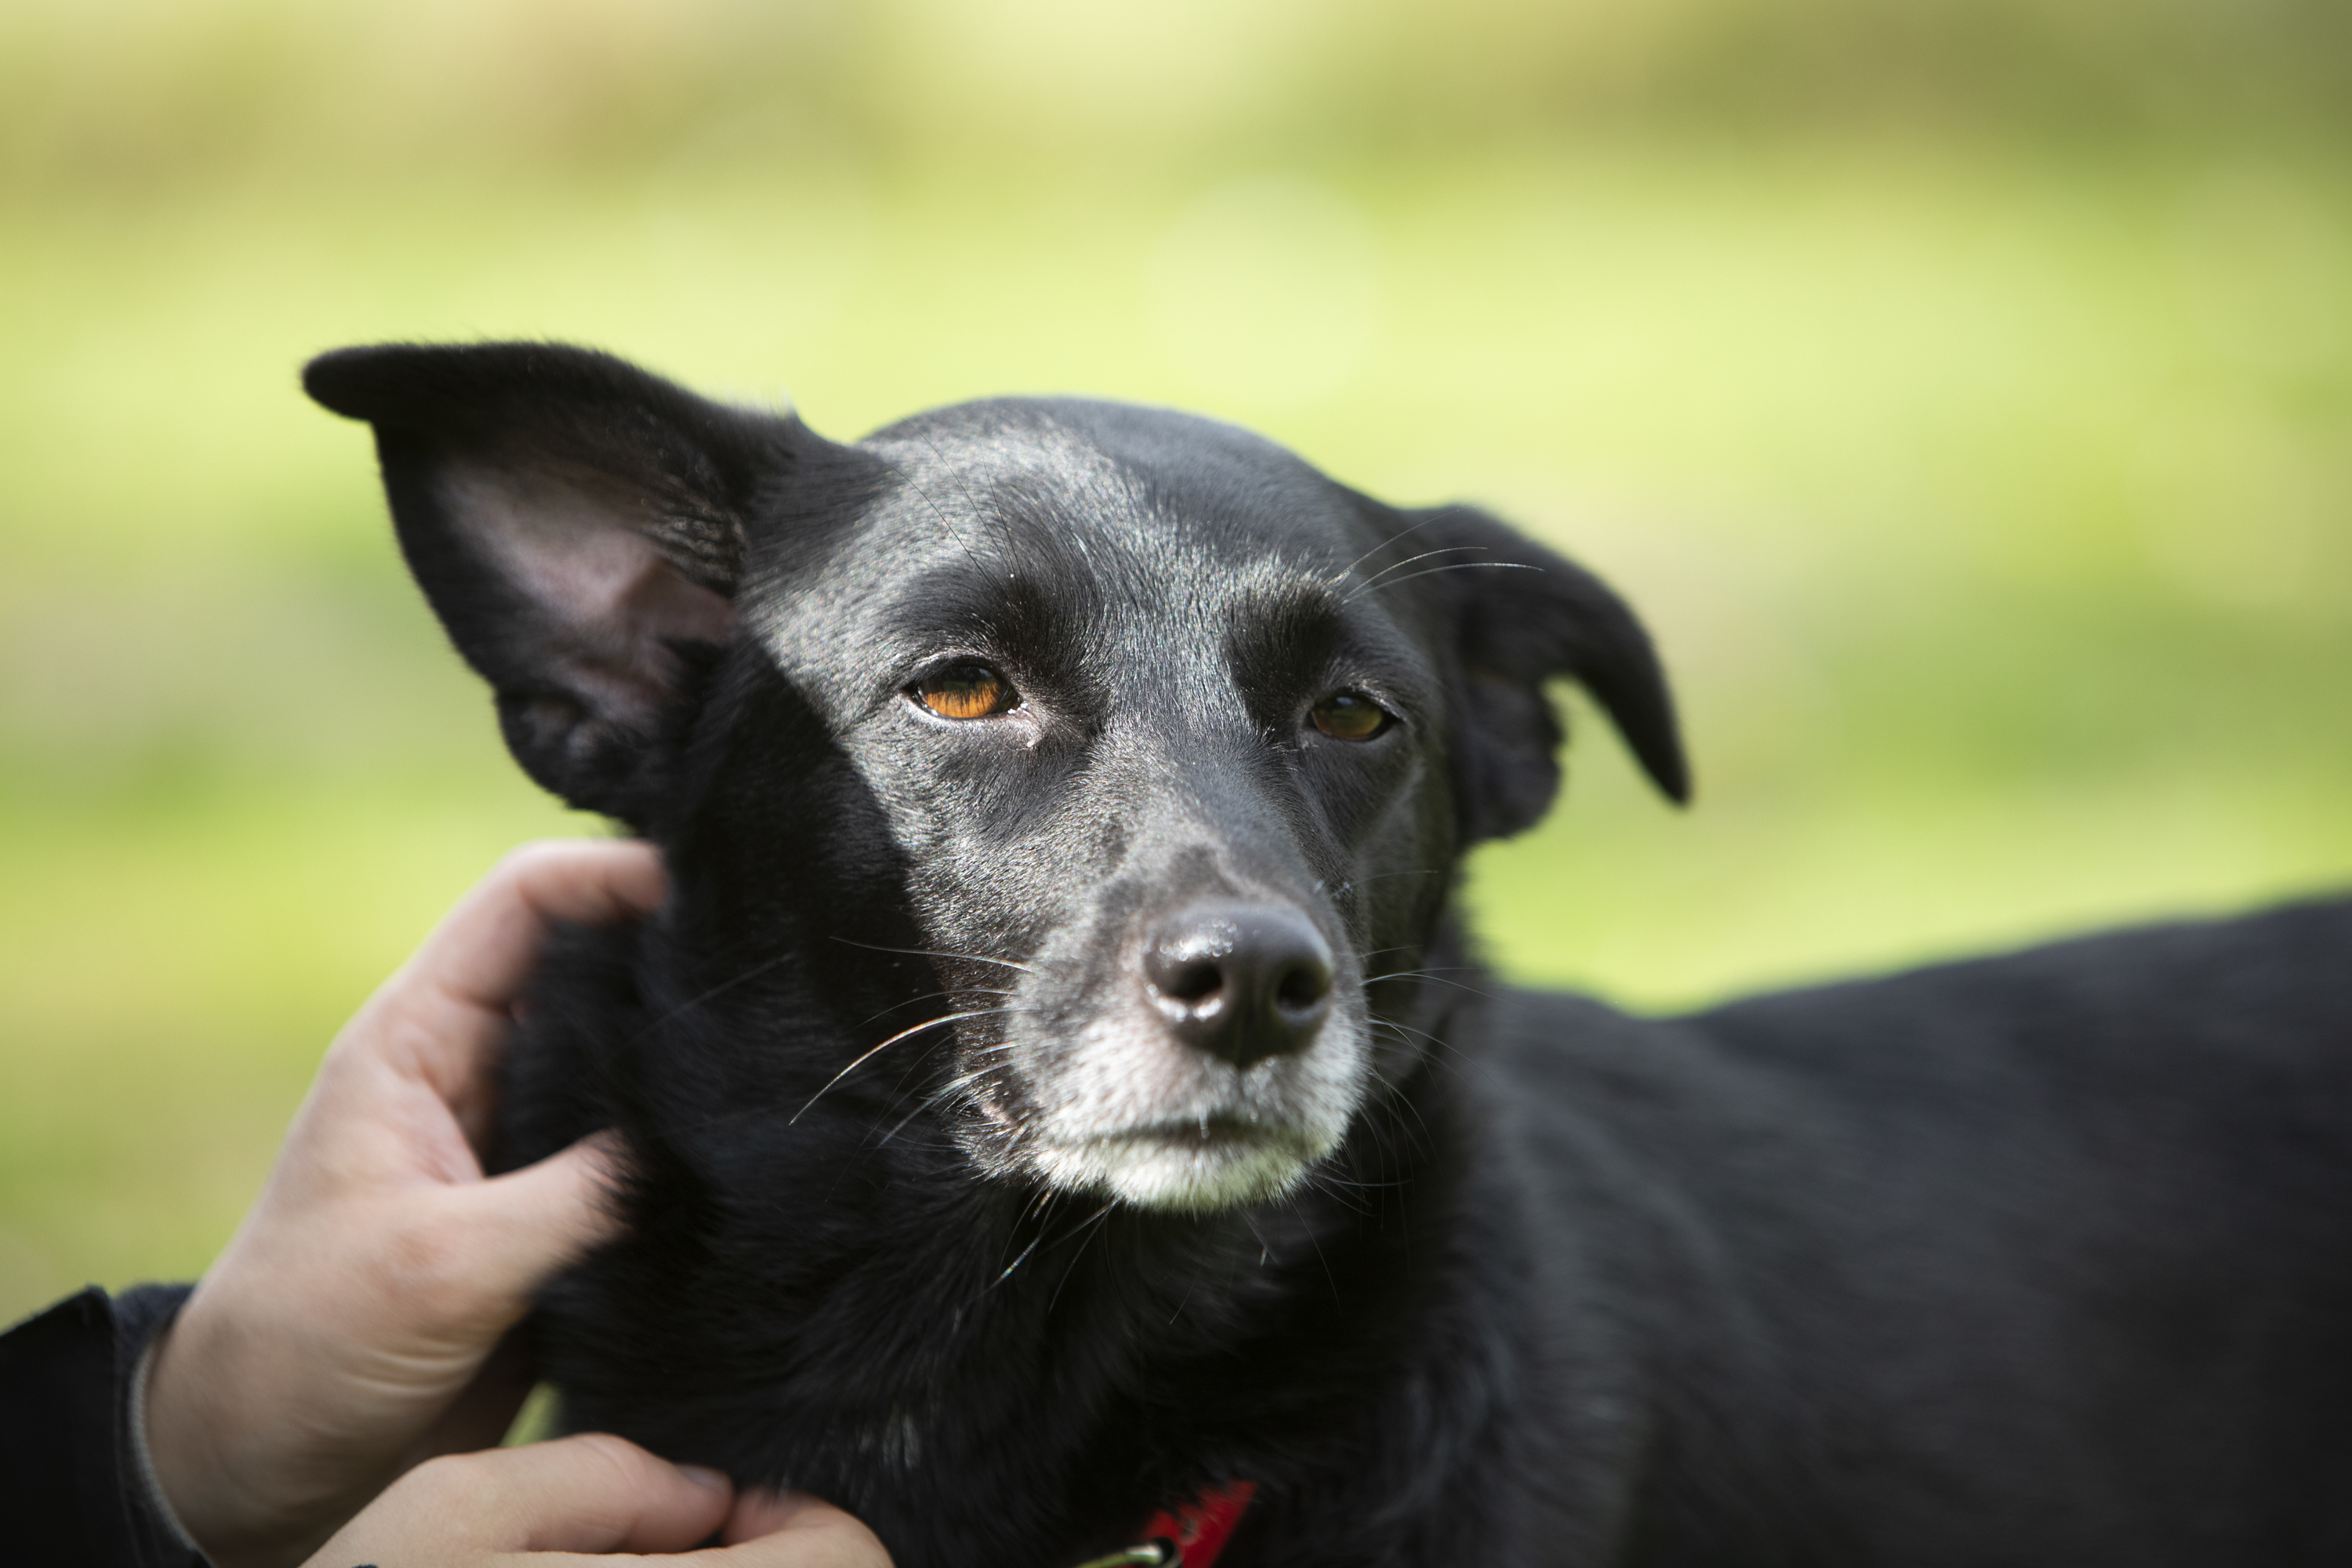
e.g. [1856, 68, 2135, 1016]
[146, 841, 666, 1568]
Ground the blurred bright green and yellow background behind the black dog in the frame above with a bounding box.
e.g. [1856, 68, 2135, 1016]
[0, 0, 2352, 1319]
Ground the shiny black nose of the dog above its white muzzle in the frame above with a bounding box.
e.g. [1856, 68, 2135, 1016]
[1143, 902, 1331, 1067]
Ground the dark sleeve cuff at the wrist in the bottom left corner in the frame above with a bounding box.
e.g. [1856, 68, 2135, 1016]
[0, 1286, 205, 1568]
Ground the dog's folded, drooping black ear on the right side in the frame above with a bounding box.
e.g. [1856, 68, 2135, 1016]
[1367, 506, 1691, 841]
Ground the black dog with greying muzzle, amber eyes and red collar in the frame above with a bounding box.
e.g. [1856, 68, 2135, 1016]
[306, 346, 2352, 1568]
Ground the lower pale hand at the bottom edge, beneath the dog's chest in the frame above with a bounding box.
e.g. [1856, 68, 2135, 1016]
[292, 1434, 889, 1568]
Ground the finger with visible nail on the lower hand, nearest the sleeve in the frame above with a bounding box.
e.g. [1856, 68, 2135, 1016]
[308, 1432, 734, 1568]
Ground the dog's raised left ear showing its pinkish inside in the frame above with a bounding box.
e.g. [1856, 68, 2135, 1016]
[303, 343, 821, 825]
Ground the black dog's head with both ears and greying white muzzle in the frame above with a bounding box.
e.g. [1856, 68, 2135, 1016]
[306, 346, 1686, 1210]
